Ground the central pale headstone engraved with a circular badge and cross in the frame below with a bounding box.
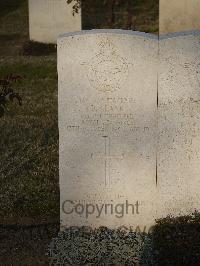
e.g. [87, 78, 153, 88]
[58, 30, 158, 230]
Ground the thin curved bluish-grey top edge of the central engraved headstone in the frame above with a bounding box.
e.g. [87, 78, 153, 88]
[57, 29, 158, 42]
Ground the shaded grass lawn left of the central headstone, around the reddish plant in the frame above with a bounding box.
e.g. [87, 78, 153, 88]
[0, 56, 59, 224]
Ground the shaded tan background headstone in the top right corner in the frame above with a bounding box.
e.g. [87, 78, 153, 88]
[159, 0, 200, 34]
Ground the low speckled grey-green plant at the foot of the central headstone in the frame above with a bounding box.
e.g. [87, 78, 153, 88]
[47, 227, 151, 266]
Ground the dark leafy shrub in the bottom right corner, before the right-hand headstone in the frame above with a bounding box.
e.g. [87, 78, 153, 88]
[152, 212, 200, 266]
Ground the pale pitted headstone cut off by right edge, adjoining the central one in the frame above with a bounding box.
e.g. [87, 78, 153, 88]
[158, 31, 200, 216]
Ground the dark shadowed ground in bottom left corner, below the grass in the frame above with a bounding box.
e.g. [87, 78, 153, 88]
[0, 223, 59, 266]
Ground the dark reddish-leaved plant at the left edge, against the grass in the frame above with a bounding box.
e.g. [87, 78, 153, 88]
[0, 74, 22, 117]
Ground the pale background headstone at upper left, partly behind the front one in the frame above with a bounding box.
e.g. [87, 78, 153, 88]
[29, 0, 81, 43]
